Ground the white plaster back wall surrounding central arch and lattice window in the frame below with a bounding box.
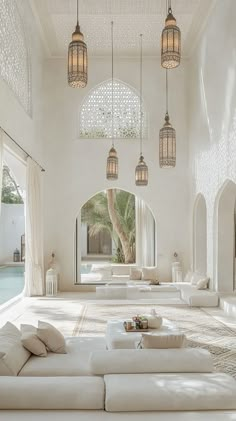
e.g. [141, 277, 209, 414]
[41, 57, 190, 290]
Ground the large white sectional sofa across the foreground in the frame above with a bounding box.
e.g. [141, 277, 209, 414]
[0, 322, 236, 414]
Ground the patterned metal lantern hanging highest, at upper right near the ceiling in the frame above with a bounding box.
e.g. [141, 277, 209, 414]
[161, 8, 181, 69]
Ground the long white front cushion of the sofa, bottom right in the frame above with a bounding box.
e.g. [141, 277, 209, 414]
[104, 373, 236, 410]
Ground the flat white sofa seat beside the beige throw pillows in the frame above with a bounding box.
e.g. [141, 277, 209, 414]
[19, 337, 106, 377]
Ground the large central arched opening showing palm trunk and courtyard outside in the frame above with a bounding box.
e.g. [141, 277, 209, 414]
[75, 189, 156, 283]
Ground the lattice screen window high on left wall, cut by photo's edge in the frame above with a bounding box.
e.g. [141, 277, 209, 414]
[0, 0, 31, 114]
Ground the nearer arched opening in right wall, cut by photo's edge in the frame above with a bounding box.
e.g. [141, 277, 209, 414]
[215, 180, 236, 293]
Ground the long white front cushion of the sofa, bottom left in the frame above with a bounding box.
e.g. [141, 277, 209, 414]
[0, 376, 104, 408]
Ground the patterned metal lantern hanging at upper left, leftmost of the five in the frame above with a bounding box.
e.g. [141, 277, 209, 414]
[68, 23, 88, 88]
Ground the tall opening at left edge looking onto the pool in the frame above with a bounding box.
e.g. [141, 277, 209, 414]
[0, 148, 26, 305]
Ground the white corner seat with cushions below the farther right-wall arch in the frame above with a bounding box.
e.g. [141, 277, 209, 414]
[174, 272, 219, 307]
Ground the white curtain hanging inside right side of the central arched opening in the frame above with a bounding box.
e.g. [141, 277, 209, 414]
[135, 197, 155, 266]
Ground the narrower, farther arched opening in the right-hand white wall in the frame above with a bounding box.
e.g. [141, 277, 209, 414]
[193, 193, 207, 274]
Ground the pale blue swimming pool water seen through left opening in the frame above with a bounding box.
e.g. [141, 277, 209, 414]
[0, 266, 25, 305]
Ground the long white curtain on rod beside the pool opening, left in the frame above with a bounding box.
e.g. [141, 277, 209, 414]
[24, 157, 44, 297]
